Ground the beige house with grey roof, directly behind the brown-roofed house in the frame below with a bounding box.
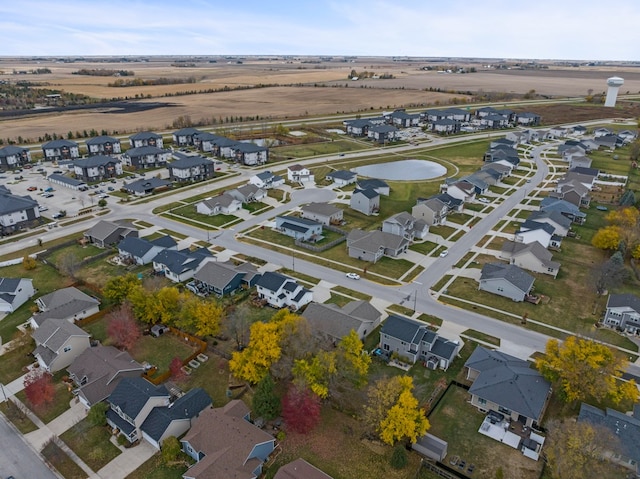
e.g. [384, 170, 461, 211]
[31, 318, 91, 373]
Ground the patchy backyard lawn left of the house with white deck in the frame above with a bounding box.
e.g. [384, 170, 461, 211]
[429, 386, 544, 479]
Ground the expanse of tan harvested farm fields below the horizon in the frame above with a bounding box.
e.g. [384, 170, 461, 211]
[0, 58, 640, 140]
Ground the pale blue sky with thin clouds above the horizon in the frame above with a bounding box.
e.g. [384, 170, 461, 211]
[0, 0, 640, 60]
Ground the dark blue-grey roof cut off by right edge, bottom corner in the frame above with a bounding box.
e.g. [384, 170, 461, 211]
[578, 403, 640, 463]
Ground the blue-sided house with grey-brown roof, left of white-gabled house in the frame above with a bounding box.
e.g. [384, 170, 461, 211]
[187, 261, 260, 297]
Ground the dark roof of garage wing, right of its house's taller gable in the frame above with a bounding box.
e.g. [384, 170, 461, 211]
[140, 388, 211, 441]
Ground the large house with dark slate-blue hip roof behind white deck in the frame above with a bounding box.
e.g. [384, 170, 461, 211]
[464, 346, 551, 427]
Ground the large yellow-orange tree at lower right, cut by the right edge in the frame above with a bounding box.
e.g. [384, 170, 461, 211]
[536, 336, 638, 404]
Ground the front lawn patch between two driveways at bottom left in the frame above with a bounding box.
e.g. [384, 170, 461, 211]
[60, 418, 122, 471]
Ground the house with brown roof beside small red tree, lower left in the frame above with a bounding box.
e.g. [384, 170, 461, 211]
[67, 345, 144, 409]
